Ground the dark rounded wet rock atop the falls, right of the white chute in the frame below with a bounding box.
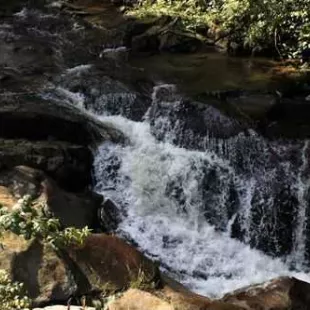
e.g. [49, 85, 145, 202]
[149, 99, 245, 145]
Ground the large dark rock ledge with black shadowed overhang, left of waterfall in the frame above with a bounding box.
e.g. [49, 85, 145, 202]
[0, 96, 124, 191]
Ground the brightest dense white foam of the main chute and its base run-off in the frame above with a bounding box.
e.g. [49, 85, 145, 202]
[95, 116, 310, 297]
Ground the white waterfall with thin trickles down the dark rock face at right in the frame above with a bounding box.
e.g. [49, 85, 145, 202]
[47, 68, 309, 296]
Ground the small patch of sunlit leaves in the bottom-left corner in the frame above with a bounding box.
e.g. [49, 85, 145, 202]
[0, 270, 31, 310]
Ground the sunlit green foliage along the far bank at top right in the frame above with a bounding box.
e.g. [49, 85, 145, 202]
[128, 0, 310, 58]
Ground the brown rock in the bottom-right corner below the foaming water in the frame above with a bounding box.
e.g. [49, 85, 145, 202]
[222, 277, 310, 310]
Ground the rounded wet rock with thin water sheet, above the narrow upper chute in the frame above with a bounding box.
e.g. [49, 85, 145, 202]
[59, 68, 151, 121]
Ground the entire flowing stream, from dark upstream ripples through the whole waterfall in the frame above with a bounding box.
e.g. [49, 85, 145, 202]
[0, 4, 310, 297]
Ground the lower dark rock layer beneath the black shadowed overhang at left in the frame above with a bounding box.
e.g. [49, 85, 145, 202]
[0, 138, 93, 191]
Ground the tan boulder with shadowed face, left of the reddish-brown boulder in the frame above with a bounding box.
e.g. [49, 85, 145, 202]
[0, 238, 77, 306]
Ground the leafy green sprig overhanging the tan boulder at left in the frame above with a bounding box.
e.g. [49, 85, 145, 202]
[0, 195, 90, 248]
